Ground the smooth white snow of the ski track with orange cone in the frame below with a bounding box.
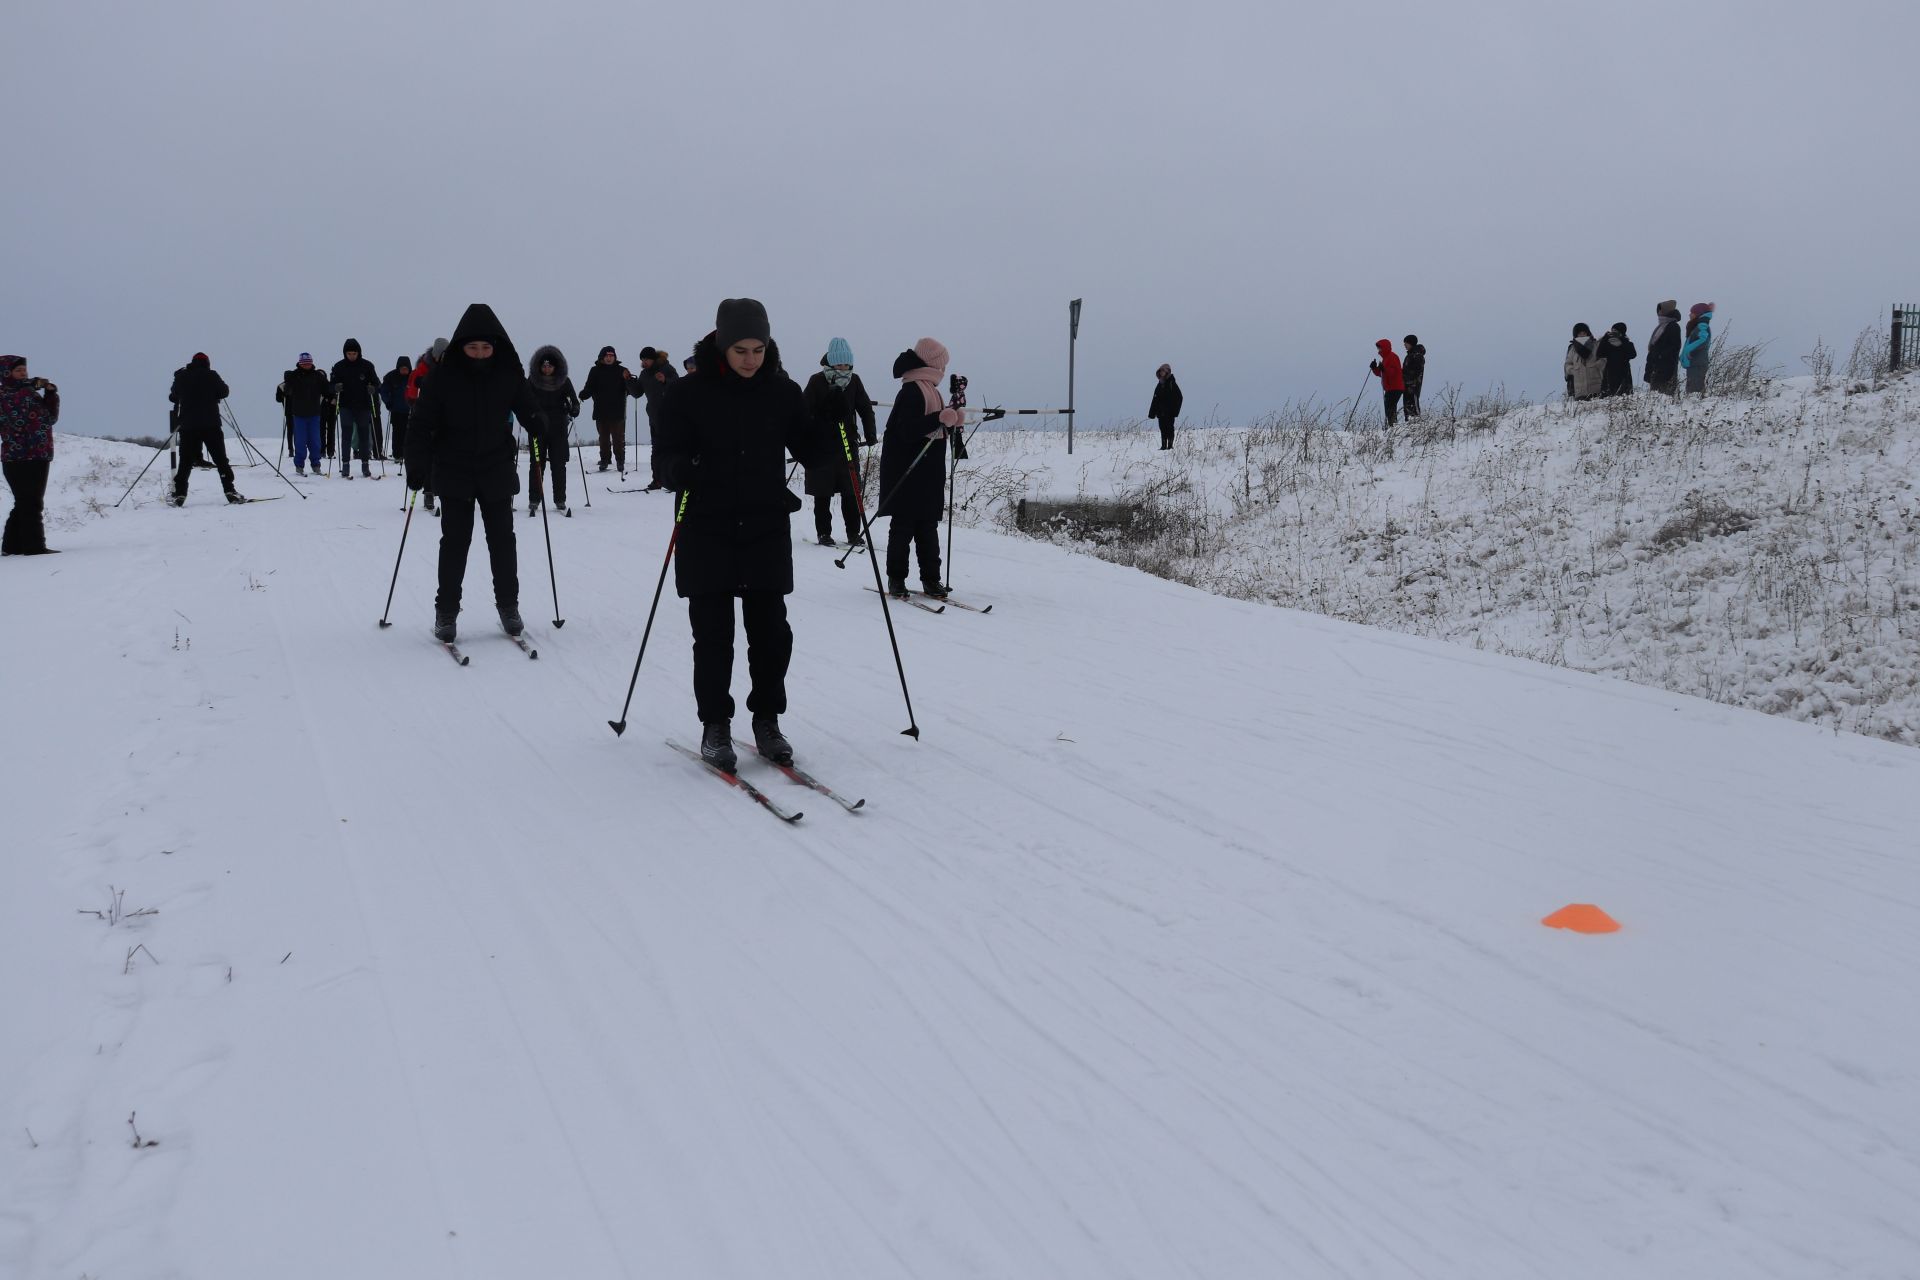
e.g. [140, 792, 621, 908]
[0, 435, 1920, 1280]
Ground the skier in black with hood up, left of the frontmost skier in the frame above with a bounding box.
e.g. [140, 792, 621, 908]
[407, 303, 541, 643]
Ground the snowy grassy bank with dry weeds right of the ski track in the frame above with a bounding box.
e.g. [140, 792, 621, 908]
[960, 378, 1920, 745]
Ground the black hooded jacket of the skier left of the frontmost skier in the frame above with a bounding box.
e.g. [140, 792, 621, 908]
[407, 303, 541, 499]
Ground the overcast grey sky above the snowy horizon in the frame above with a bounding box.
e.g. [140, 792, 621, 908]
[0, 0, 1920, 438]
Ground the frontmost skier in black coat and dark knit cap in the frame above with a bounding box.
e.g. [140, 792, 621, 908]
[653, 297, 812, 773]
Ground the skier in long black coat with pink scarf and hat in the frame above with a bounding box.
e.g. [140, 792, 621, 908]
[874, 338, 960, 597]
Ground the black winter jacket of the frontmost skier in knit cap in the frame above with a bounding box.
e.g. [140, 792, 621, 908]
[653, 336, 812, 597]
